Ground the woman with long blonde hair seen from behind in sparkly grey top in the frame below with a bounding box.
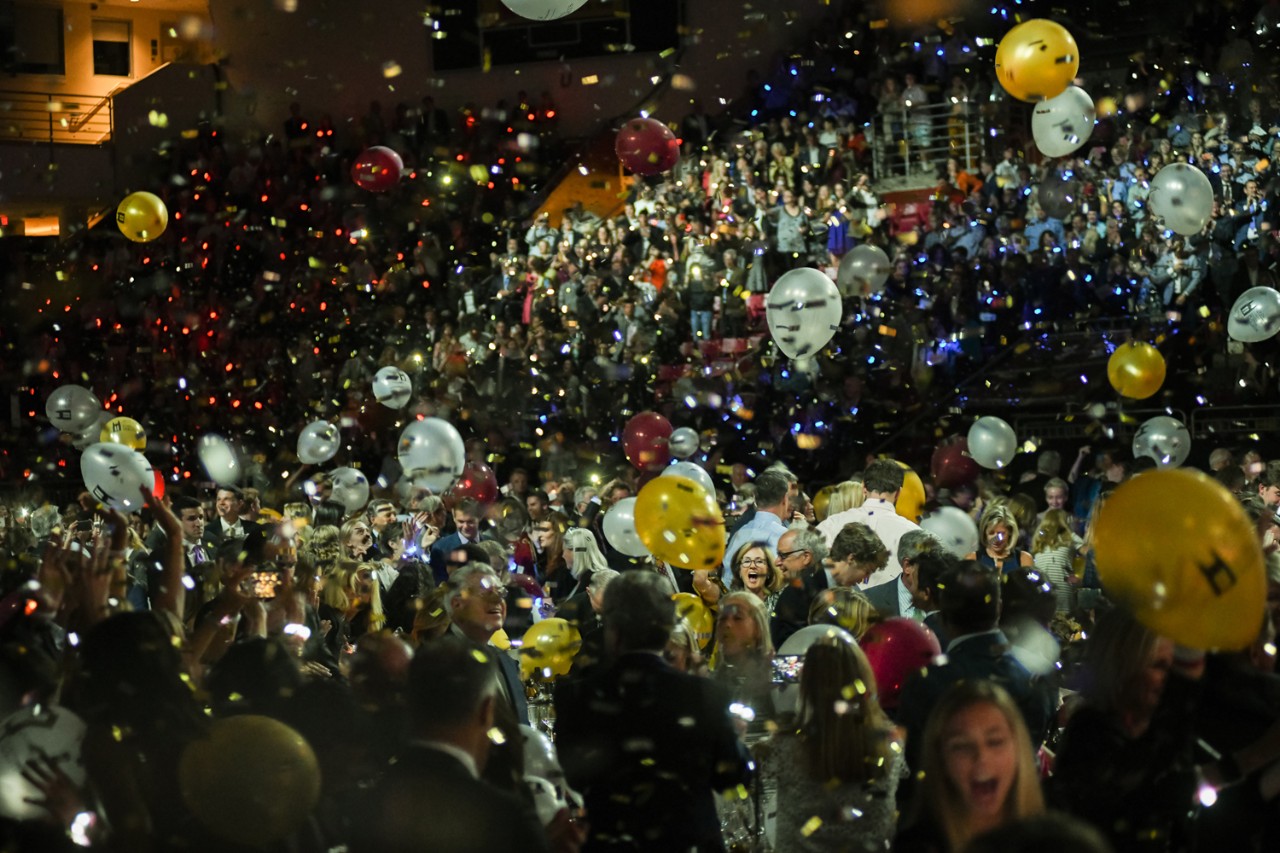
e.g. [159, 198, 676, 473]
[759, 637, 905, 853]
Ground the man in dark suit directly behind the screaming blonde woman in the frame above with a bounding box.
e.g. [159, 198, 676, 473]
[899, 560, 1055, 768]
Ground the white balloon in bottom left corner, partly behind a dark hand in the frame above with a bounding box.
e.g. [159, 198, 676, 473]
[0, 701, 87, 821]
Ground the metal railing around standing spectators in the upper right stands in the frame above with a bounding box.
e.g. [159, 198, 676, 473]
[868, 100, 986, 182]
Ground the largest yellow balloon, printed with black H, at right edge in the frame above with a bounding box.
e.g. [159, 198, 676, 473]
[1094, 467, 1267, 649]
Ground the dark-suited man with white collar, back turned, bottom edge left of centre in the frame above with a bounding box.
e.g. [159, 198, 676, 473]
[351, 637, 572, 853]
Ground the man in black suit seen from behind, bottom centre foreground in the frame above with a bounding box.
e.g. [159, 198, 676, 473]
[556, 571, 750, 850]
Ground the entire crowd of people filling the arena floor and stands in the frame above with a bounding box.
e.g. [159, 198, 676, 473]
[0, 4, 1280, 852]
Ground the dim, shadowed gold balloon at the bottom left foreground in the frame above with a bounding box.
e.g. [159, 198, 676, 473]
[178, 713, 320, 848]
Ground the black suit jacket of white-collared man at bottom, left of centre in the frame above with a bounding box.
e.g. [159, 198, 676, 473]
[351, 744, 550, 853]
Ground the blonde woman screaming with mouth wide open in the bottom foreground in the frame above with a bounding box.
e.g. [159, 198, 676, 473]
[893, 680, 1044, 853]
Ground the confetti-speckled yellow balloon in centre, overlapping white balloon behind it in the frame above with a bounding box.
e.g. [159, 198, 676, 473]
[635, 476, 724, 570]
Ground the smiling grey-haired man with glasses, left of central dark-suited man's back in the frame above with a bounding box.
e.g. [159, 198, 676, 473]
[447, 562, 529, 725]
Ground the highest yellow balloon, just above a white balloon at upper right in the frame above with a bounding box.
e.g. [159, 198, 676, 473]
[996, 18, 1080, 101]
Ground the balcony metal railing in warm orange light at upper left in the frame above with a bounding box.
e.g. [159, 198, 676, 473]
[0, 90, 115, 145]
